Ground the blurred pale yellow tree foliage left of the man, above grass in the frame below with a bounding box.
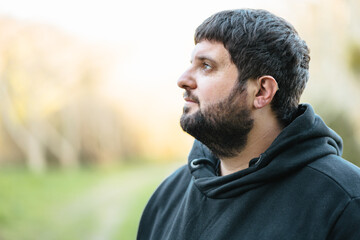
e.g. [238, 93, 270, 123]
[0, 19, 136, 172]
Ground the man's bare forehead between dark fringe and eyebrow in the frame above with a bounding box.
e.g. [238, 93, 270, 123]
[191, 40, 231, 63]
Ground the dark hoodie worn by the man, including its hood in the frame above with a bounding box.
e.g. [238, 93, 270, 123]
[137, 105, 360, 240]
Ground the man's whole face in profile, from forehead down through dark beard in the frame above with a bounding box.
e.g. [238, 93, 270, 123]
[178, 40, 253, 157]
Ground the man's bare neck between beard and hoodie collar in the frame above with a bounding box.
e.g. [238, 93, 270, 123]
[220, 109, 282, 176]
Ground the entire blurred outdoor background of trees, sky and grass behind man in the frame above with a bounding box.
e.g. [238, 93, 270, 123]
[0, 0, 360, 240]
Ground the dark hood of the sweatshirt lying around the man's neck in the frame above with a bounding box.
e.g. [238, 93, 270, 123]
[188, 104, 342, 198]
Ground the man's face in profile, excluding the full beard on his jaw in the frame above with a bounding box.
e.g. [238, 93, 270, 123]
[178, 40, 238, 114]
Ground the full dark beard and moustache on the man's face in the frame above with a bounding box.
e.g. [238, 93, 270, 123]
[180, 86, 254, 158]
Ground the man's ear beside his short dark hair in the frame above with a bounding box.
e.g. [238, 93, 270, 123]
[254, 75, 279, 109]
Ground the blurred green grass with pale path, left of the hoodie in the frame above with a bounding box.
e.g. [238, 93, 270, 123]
[0, 164, 180, 240]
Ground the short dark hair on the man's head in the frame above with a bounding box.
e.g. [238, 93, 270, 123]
[195, 9, 310, 126]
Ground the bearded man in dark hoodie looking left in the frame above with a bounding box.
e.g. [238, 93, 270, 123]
[138, 9, 360, 240]
